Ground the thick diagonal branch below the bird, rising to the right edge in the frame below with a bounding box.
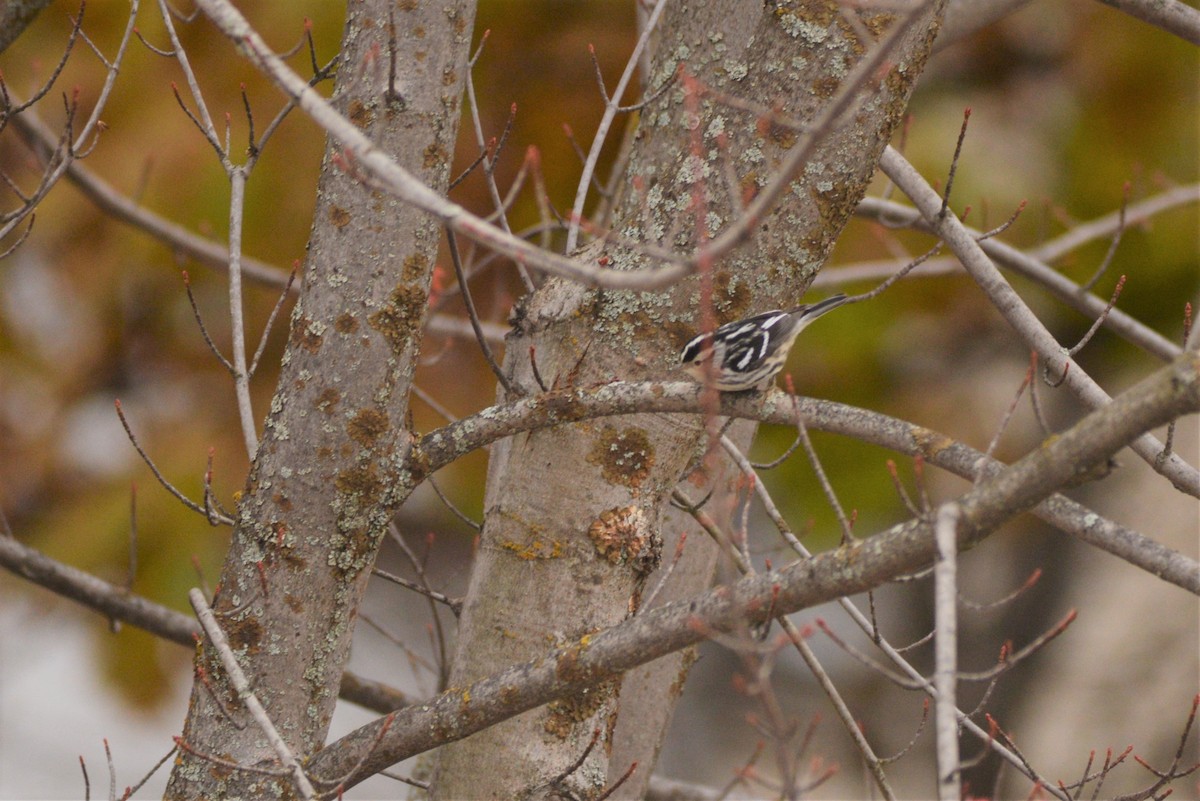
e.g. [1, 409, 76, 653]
[310, 353, 1200, 787]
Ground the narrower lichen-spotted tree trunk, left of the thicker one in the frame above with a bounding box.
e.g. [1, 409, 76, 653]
[167, 0, 474, 799]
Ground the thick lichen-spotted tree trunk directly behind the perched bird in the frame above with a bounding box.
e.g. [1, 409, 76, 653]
[433, 0, 942, 799]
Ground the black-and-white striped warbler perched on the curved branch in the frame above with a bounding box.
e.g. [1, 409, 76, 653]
[679, 295, 848, 392]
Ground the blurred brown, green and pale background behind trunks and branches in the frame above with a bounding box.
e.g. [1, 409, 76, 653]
[0, 0, 1200, 799]
